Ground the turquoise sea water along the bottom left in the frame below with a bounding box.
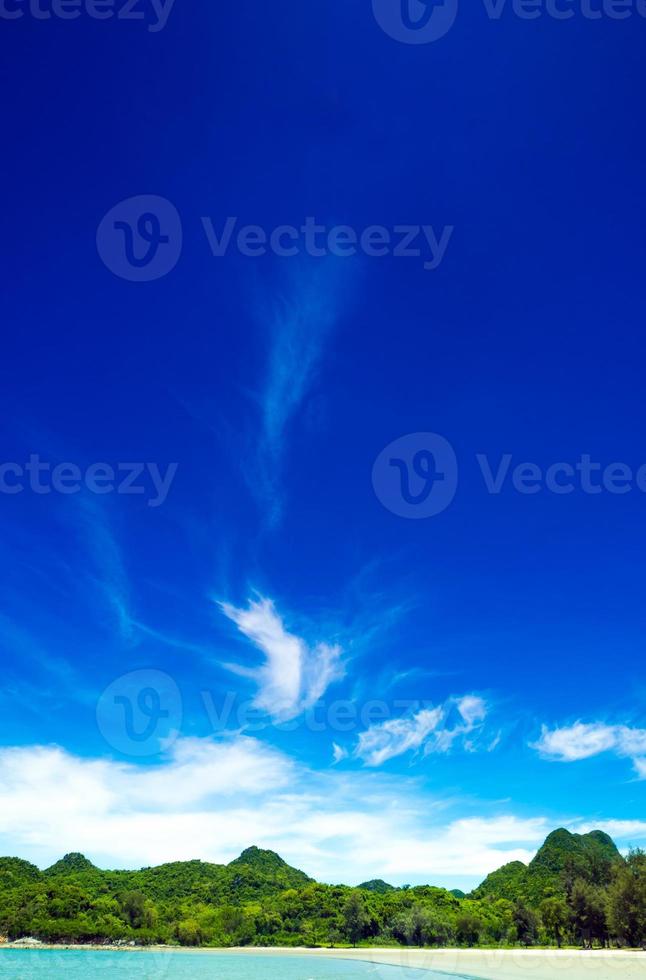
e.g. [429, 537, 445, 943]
[0, 949, 474, 980]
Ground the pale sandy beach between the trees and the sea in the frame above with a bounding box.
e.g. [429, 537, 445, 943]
[0, 943, 646, 980]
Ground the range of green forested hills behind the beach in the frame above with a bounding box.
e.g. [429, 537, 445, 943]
[0, 830, 646, 946]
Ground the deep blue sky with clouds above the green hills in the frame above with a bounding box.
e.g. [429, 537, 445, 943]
[0, 0, 646, 887]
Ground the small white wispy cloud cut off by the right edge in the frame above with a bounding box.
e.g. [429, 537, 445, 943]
[531, 721, 646, 779]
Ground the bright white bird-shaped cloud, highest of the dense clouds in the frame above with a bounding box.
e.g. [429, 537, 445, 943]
[220, 597, 345, 721]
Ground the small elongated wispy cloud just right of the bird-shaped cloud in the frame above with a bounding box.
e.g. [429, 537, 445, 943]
[353, 695, 487, 767]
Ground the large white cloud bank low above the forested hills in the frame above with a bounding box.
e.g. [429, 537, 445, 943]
[0, 736, 551, 884]
